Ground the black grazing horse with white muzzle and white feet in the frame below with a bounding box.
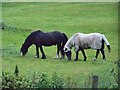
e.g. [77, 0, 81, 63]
[20, 30, 68, 59]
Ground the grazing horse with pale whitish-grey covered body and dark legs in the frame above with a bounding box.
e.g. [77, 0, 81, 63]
[64, 33, 110, 61]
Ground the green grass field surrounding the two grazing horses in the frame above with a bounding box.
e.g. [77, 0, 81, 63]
[2, 2, 118, 88]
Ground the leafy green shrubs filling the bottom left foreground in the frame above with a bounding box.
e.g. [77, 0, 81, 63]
[2, 69, 64, 90]
